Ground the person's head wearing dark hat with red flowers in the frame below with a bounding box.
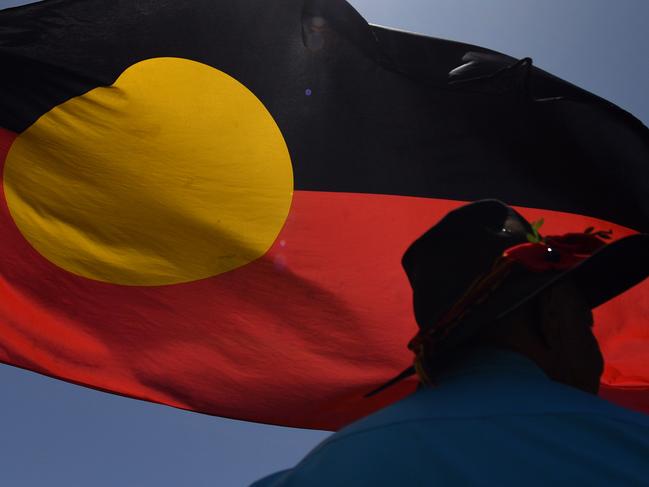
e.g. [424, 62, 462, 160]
[367, 200, 649, 396]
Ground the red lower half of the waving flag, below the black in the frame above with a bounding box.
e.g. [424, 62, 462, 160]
[0, 134, 649, 429]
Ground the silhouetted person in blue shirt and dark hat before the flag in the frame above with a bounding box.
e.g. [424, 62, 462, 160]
[254, 200, 649, 487]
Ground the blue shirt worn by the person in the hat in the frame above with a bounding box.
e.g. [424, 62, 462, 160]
[253, 348, 649, 487]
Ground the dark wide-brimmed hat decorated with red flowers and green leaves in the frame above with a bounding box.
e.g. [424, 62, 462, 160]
[368, 200, 649, 396]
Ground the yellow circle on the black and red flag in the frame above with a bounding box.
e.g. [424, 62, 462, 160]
[3, 58, 293, 286]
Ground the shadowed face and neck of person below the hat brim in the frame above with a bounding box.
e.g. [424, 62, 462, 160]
[460, 279, 604, 394]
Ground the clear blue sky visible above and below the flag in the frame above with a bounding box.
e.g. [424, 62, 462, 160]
[0, 0, 649, 487]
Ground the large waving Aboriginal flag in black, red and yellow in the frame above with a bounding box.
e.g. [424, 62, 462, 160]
[0, 0, 649, 429]
